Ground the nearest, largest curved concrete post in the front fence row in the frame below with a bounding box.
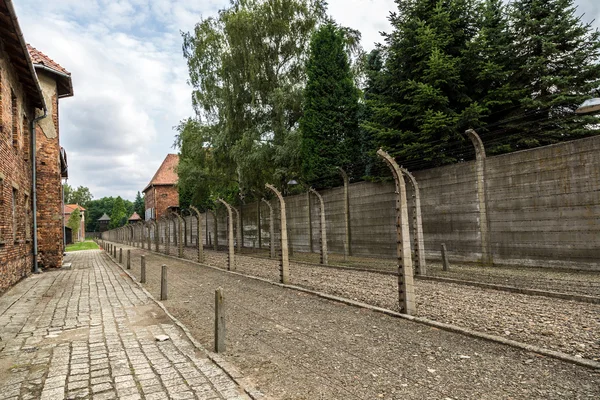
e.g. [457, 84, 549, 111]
[377, 149, 417, 315]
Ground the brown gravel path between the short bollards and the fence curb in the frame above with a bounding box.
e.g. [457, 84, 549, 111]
[110, 250, 600, 399]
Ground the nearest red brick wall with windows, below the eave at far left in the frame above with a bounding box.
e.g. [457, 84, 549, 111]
[0, 51, 34, 292]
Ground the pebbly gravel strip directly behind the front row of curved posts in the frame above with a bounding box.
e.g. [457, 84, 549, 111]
[161, 245, 600, 361]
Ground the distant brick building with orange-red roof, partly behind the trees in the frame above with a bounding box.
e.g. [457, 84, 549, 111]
[143, 154, 179, 221]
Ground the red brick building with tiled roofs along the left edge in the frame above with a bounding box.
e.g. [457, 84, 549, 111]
[0, 0, 72, 292]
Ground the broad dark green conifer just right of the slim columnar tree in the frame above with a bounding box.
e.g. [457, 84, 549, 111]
[363, 0, 485, 167]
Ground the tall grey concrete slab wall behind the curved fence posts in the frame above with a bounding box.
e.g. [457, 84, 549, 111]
[170, 136, 600, 270]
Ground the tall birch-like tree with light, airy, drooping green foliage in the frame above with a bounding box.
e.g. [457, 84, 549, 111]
[180, 0, 325, 197]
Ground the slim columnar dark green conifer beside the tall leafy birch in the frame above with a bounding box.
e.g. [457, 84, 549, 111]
[300, 22, 363, 188]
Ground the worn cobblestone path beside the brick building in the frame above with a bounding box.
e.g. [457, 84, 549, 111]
[0, 250, 248, 400]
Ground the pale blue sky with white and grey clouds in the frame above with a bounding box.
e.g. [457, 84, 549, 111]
[13, 0, 600, 200]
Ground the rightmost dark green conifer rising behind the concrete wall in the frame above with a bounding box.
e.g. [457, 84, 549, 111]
[501, 0, 600, 151]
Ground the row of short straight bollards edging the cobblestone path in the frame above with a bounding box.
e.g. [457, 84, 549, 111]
[102, 241, 225, 353]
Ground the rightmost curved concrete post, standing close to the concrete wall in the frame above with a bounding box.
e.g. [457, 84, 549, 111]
[465, 129, 494, 265]
